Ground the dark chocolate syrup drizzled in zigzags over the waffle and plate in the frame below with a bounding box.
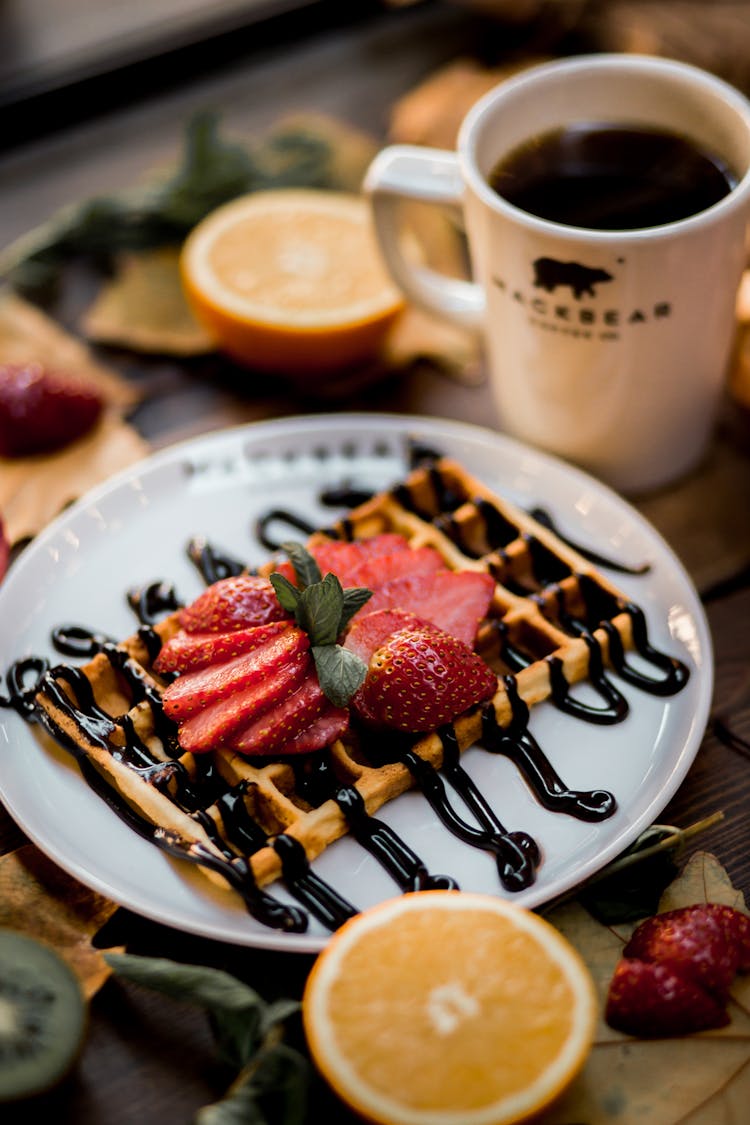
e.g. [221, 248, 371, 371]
[0, 446, 688, 933]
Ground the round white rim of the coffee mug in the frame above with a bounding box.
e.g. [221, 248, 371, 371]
[457, 52, 750, 243]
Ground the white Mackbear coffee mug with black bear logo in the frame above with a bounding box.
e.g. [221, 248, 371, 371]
[364, 54, 750, 493]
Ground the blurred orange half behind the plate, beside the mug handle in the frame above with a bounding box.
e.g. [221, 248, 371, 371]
[181, 189, 404, 374]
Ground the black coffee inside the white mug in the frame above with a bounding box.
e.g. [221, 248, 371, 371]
[488, 123, 737, 231]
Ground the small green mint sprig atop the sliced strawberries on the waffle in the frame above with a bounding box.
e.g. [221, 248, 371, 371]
[269, 542, 372, 707]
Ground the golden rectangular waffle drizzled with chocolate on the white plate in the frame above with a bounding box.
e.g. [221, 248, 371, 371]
[29, 458, 687, 929]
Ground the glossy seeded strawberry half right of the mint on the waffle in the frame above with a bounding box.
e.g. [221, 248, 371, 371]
[352, 624, 497, 732]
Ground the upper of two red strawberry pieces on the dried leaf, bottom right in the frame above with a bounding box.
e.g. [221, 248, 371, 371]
[623, 903, 750, 1000]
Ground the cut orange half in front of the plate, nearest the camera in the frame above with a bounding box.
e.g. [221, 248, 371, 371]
[302, 891, 596, 1125]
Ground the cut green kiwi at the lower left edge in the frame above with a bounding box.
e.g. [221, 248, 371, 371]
[0, 928, 87, 1101]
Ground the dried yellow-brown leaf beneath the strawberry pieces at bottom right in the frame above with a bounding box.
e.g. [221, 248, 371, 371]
[541, 852, 750, 1125]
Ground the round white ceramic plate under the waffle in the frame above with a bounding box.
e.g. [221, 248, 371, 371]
[0, 414, 713, 952]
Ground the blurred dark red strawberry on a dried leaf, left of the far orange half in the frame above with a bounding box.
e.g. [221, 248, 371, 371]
[0, 362, 103, 457]
